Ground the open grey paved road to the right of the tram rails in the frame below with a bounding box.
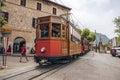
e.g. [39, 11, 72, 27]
[39, 52, 120, 80]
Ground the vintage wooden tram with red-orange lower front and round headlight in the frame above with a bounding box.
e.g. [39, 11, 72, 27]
[34, 16, 89, 64]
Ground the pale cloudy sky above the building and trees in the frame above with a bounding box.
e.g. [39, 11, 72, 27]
[52, 0, 120, 39]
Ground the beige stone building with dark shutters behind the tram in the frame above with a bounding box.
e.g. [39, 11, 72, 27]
[0, 0, 71, 53]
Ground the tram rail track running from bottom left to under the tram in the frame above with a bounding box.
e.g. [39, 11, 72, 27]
[0, 60, 75, 80]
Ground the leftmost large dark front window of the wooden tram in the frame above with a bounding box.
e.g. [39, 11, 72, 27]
[40, 24, 49, 38]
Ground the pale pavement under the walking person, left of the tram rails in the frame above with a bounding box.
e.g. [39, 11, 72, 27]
[0, 54, 38, 77]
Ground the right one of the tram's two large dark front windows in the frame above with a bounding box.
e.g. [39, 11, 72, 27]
[52, 24, 60, 37]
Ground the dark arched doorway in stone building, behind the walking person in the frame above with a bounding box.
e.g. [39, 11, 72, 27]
[13, 37, 26, 53]
